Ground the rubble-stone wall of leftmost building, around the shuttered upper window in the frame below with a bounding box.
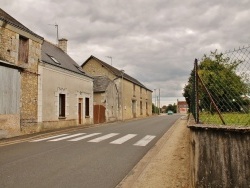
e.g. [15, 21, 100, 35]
[0, 22, 42, 133]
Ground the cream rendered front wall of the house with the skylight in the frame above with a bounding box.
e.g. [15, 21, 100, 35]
[38, 63, 93, 129]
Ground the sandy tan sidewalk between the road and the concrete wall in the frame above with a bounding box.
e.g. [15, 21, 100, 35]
[116, 119, 190, 188]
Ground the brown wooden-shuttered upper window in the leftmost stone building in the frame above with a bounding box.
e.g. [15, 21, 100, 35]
[18, 36, 29, 63]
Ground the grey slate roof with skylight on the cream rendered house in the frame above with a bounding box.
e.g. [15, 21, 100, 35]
[42, 41, 92, 78]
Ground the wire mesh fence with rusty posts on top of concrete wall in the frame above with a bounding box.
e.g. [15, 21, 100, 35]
[187, 46, 250, 126]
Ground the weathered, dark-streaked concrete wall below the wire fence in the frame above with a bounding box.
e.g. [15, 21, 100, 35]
[190, 125, 250, 187]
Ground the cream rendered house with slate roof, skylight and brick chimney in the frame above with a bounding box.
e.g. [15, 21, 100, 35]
[38, 39, 93, 129]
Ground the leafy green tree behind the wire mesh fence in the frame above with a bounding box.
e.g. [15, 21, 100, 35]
[183, 51, 247, 112]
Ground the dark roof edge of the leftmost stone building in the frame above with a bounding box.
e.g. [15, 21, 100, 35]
[0, 8, 43, 40]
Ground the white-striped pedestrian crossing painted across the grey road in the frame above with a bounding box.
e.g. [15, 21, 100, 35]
[30, 133, 156, 146]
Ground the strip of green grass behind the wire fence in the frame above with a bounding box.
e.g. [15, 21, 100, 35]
[200, 112, 250, 126]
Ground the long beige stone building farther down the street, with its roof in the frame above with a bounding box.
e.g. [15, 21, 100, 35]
[81, 56, 152, 120]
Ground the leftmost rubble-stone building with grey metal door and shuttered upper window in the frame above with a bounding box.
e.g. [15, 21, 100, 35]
[0, 8, 43, 135]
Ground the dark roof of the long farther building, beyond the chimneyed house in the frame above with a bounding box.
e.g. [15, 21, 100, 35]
[81, 55, 152, 91]
